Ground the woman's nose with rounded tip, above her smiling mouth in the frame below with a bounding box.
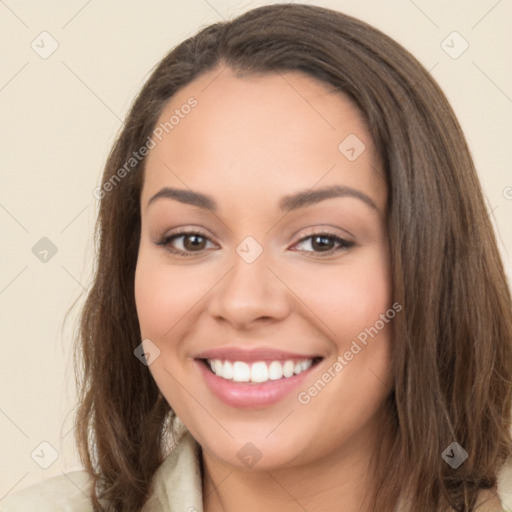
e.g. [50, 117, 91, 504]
[209, 247, 291, 330]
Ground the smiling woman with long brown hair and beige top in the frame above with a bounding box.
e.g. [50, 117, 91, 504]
[2, 4, 512, 512]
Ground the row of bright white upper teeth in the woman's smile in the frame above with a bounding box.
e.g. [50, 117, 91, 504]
[207, 359, 313, 383]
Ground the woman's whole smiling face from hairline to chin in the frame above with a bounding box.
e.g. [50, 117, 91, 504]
[135, 68, 399, 468]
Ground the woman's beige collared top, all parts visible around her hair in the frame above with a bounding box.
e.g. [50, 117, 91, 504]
[0, 431, 511, 512]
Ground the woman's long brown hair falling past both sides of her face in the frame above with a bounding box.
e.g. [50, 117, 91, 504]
[75, 4, 512, 512]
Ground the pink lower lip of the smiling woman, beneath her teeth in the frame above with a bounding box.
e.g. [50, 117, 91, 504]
[196, 360, 317, 408]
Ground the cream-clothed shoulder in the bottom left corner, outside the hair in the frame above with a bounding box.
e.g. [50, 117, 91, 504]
[0, 470, 93, 512]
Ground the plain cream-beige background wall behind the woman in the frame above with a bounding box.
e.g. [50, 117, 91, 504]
[0, 0, 512, 506]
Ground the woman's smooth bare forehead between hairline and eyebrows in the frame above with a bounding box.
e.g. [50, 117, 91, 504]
[143, 68, 385, 214]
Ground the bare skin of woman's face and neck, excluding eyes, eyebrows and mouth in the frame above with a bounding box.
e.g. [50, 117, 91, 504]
[135, 67, 392, 512]
